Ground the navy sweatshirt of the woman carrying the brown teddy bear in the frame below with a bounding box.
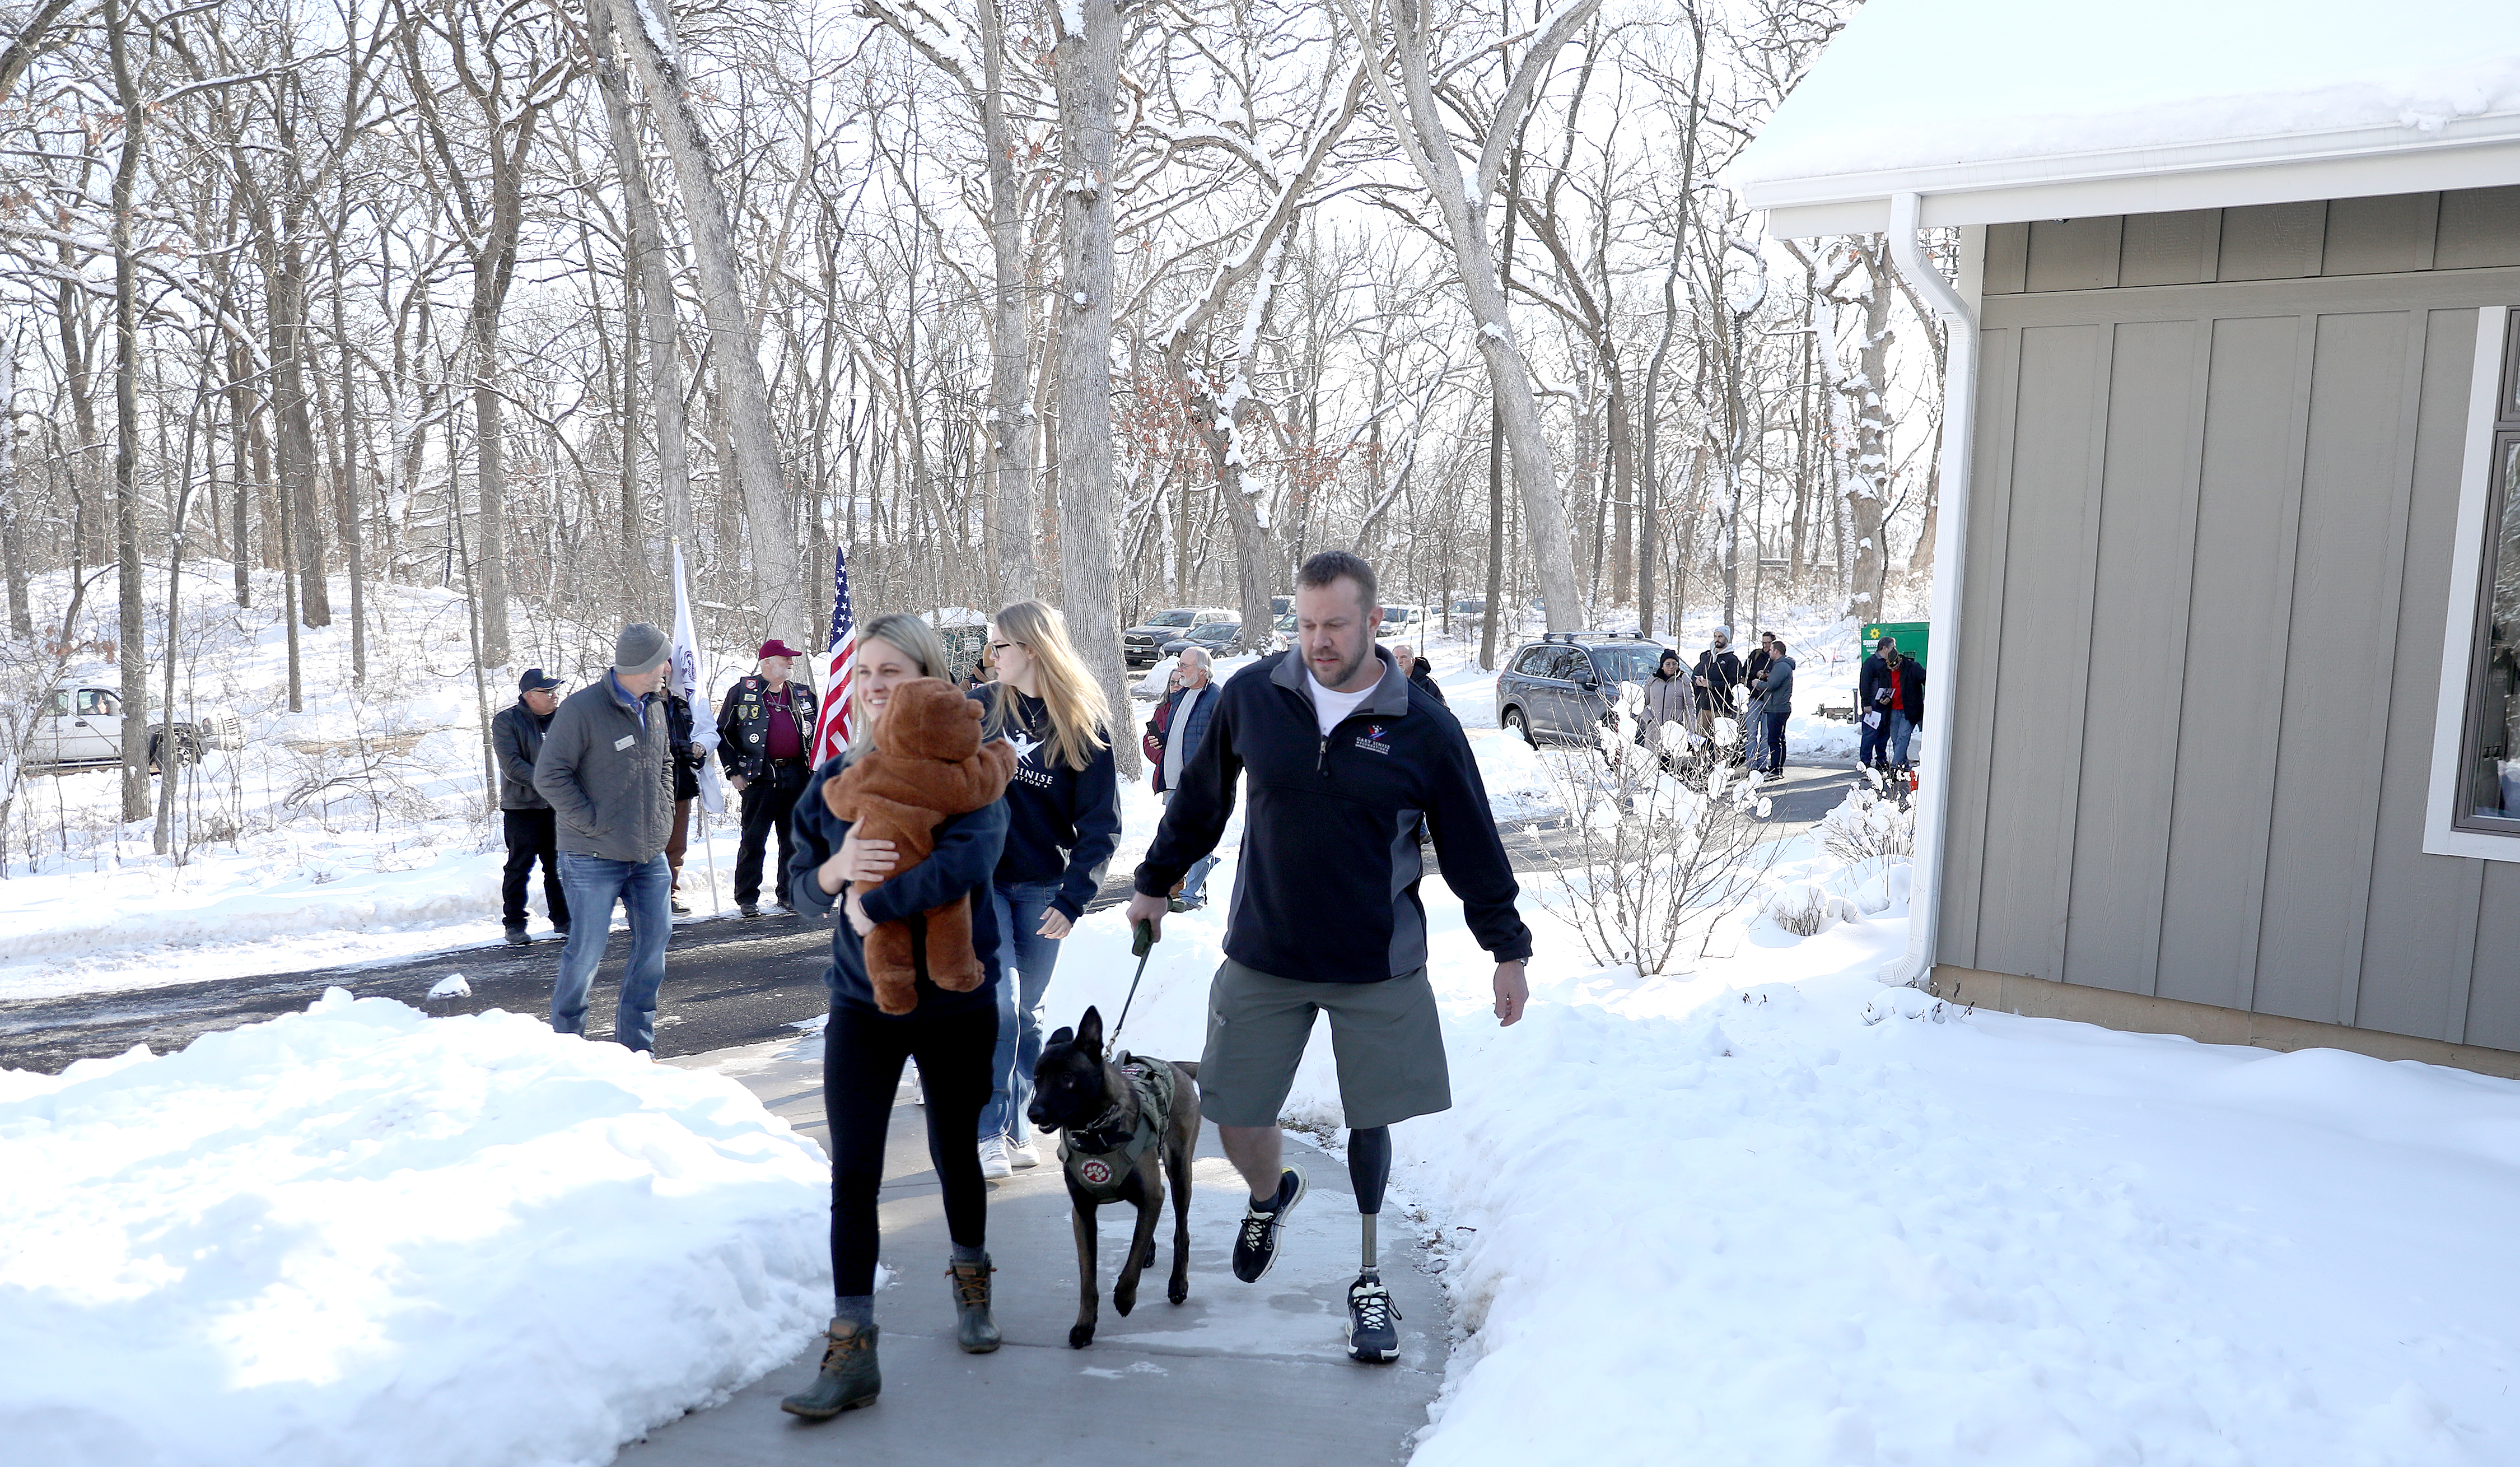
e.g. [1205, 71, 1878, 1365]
[789, 754, 1006, 1018]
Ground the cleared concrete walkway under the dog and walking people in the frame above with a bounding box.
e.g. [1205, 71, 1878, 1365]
[640, 1036, 1449, 1467]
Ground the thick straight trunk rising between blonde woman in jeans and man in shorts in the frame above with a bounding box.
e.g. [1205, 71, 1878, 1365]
[1051, 0, 1139, 779]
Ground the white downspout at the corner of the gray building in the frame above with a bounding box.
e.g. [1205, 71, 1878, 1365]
[1880, 194, 1978, 986]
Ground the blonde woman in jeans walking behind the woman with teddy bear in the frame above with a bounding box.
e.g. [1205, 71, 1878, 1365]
[973, 600, 1119, 1177]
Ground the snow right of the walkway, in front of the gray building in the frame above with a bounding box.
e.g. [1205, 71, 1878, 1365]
[1051, 842, 2520, 1467]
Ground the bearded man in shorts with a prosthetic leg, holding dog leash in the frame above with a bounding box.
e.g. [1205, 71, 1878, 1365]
[1129, 552, 1532, 1361]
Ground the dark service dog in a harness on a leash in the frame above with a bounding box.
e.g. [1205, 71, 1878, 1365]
[1026, 1008, 1200, 1349]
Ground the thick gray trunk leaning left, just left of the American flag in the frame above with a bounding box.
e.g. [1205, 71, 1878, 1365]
[608, 0, 796, 655]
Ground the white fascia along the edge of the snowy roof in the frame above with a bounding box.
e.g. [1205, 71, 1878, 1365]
[1742, 114, 2520, 240]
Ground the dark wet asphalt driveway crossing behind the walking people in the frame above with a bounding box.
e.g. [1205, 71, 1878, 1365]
[0, 766, 1858, 1074]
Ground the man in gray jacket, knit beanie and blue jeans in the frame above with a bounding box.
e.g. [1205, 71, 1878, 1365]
[534, 623, 673, 1054]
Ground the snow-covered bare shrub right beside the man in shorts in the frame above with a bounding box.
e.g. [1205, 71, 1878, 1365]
[1535, 683, 1774, 973]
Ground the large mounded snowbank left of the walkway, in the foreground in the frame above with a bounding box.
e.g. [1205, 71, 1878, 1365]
[0, 988, 832, 1467]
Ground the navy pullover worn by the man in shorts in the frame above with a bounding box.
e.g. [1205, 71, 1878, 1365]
[1137, 648, 1532, 983]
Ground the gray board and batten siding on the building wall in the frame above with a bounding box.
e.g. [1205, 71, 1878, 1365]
[1935, 187, 2520, 1051]
